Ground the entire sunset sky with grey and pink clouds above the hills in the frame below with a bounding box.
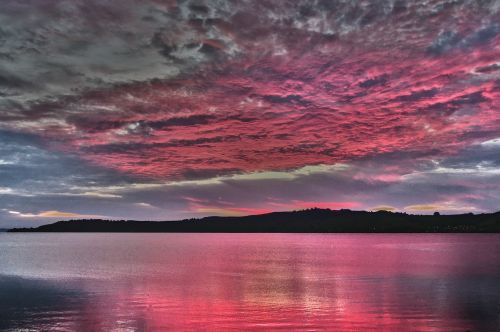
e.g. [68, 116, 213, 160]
[0, 0, 500, 227]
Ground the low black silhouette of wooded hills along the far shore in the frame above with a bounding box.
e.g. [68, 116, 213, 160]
[9, 209, 500, 233]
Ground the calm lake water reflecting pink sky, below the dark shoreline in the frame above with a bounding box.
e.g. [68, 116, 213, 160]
[0, 234, 500, 331]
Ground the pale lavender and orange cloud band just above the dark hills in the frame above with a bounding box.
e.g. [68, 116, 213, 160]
[1, 140, 500, 226]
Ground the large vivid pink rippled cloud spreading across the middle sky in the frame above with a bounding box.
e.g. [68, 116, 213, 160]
[4, 3, 500, 181]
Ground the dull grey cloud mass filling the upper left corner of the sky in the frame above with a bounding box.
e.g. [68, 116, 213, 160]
[0, 0, 243, 112]
